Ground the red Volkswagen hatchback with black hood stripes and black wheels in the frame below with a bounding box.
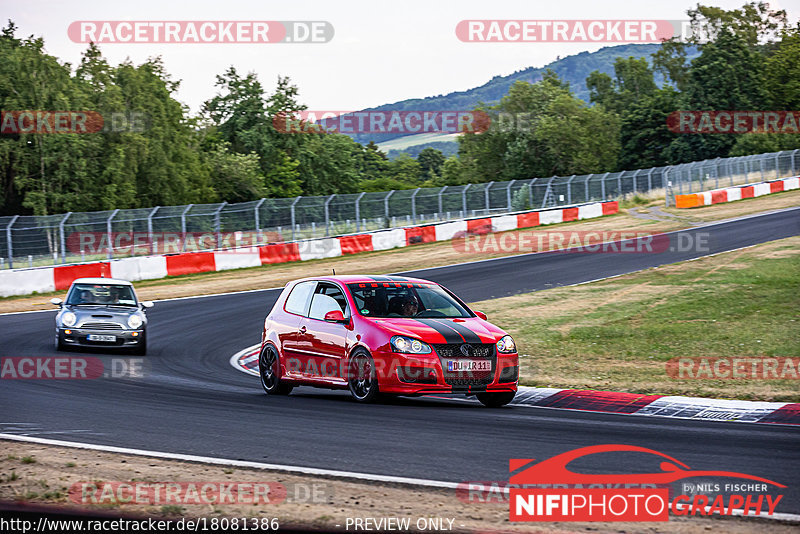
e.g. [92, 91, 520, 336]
[258, 275, 519, 407]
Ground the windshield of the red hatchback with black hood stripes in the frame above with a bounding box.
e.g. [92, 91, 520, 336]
[348, 282, 472, 318]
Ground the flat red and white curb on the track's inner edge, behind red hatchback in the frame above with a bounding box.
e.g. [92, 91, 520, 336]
[230, 344, 800, 425]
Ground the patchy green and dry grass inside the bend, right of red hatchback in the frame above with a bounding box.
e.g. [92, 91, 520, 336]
[472, 237, 800, 402]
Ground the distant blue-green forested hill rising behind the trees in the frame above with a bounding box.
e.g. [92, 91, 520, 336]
[351, 44, 697, 144]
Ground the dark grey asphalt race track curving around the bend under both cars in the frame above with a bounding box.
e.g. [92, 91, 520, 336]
[0, 208, 800, 514]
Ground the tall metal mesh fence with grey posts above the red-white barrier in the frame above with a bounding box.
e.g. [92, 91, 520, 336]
[0, 150, 800, 268]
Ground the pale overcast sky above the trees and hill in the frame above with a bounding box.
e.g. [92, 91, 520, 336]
[6, 0, 800, 112]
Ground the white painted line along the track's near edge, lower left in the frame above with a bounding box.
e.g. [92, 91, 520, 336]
[0, 434, 458, 489]
